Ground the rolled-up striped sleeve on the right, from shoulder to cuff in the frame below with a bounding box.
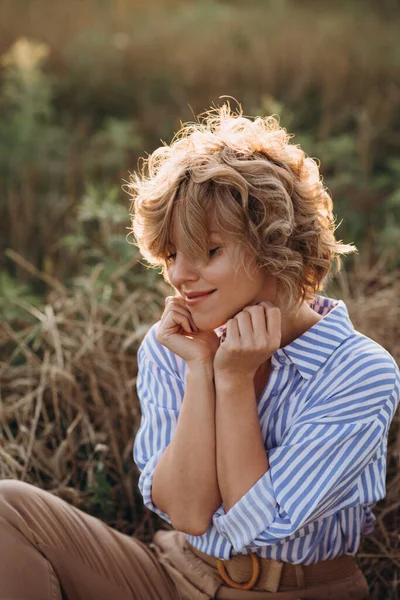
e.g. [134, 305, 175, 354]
[213, 360, 398, 552]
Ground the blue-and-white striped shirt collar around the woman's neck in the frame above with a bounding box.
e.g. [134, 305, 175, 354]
[216, 296, 354, 379]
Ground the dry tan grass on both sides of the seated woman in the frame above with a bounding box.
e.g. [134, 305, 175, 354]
[0, 255, 400, 600]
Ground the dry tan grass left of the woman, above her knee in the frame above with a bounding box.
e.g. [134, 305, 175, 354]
[0, 260, 167, 532]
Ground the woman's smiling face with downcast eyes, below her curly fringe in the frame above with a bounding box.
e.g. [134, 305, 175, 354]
[167, 216, 276, 330]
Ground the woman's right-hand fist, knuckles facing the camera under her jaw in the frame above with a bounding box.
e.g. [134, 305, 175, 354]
[214, 302, 281, 378]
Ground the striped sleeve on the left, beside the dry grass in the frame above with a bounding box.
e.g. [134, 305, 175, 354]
[133, 330, 184, 523]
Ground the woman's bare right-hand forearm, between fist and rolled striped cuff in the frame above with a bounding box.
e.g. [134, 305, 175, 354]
[215, 376, 269, 512]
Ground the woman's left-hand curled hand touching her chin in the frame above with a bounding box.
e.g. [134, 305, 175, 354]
[156, 296, 219, 365]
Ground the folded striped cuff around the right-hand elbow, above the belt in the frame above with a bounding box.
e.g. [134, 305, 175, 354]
[213, 469, 278, 552]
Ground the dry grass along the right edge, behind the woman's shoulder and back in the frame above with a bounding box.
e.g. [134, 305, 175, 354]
[332, 261, 400, 600]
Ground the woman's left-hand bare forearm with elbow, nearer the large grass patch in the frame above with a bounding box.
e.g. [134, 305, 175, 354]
[152, 364, 221, 535]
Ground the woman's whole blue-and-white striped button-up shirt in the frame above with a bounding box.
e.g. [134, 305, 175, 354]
[134, 296, 400, 565]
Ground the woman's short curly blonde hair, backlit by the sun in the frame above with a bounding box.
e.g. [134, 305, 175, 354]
[128, 102, 356, 311]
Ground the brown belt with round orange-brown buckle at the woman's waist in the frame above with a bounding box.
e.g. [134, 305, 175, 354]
[187, 542, 358, 592]
